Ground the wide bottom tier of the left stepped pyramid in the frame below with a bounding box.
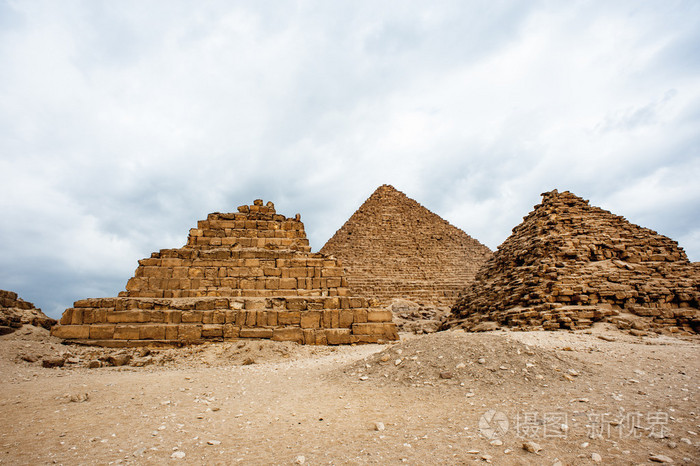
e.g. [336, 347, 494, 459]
[51, 296, 399, 347]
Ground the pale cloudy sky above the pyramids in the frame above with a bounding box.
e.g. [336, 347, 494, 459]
[0, 0, 700, 317]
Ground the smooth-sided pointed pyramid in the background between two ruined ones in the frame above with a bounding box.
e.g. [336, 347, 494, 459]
[321, 185, 491, 306]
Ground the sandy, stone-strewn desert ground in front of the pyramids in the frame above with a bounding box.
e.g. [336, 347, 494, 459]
[0, 324, 700, 465]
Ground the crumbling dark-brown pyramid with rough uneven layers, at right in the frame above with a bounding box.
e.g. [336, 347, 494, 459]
[448, 190, 700, 332]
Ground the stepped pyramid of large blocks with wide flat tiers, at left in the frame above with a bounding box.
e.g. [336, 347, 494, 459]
[52, 199, 398, 346]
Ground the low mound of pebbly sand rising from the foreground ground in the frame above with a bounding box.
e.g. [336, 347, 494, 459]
[336, 331, 589, 390]
